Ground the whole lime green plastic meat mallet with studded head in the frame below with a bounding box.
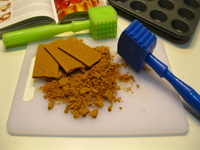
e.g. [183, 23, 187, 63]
[2, 5, 117, 46]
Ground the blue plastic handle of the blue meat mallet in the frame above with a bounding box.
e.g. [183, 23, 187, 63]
[145, 53, 200, 115]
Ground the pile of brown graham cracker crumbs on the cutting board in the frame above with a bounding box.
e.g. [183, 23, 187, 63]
[35, 37, 135, 118]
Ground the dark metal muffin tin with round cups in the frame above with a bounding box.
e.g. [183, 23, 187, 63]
[108, 0, 200, 39]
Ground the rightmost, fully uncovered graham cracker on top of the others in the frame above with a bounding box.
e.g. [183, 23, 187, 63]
[59, 37, 101, 68]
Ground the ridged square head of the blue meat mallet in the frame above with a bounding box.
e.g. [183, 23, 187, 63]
[118, 20, 157, 72]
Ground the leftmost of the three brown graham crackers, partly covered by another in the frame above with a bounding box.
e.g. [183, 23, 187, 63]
[32, 44, 59, 78]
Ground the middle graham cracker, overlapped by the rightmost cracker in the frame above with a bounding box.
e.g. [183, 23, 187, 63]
[45, 39, 85, 74]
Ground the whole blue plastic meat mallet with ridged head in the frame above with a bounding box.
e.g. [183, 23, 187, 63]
[117, 20, 200, 115]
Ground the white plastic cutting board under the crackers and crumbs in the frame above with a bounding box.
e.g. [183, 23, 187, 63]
[7, 37, 188, 136]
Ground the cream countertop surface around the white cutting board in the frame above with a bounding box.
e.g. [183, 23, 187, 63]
[0, 9, 200, 150]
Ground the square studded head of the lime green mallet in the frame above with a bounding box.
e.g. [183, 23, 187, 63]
[88, 5, 117, 40]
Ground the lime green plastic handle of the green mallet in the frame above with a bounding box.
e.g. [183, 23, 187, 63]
[2, 20, 91, 46]
